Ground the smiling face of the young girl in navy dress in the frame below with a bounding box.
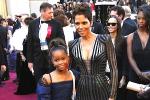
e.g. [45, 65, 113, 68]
[52, 50, 69, 71]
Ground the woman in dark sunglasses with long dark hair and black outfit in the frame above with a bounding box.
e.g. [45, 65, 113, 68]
[107, 16, 128, 100]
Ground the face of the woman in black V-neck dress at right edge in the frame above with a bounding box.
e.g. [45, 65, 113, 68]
[137, 11, 146, 27]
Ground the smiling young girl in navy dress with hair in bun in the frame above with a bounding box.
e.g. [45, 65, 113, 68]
[39, 40, 79, 100]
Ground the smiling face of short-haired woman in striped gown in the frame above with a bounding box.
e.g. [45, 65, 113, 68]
[75, 15, 91, 37]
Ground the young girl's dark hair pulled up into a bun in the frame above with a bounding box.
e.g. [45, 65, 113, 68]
[49, 38, 67, 57]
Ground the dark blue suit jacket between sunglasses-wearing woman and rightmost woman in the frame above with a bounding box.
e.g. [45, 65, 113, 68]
[121, 18, 137, 36]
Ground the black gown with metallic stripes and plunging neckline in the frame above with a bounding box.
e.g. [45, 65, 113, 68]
[69, 34, 118, 100]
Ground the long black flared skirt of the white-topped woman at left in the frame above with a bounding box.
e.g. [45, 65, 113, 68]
[15, 40, 36, 95]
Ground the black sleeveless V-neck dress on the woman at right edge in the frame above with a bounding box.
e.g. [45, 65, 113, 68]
[127, 32, 150, 100]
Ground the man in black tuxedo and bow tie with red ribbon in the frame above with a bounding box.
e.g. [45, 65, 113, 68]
[27, 3, 65, 81]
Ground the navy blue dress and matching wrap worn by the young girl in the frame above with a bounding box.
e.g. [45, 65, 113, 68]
[37, 70, 80, 100]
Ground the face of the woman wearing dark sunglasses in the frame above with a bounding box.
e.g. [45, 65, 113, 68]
[107, 18, 117, 33]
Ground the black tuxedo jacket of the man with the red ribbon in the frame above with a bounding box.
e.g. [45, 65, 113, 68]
[27, 18, 65, 62]
